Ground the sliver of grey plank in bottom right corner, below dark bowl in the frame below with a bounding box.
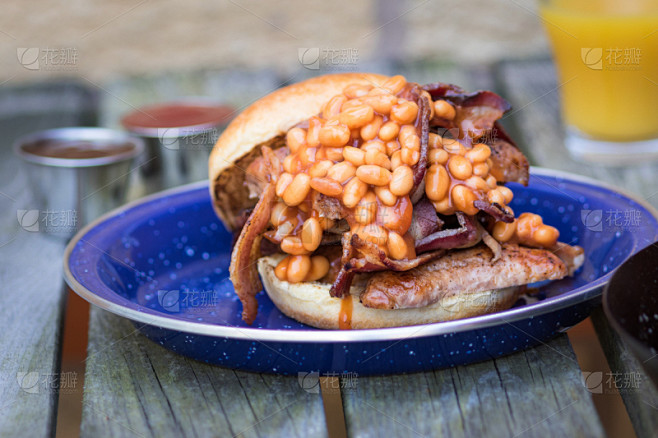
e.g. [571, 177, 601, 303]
[592, 309, 658, 438]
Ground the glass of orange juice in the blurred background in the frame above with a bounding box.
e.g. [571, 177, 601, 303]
[540, 0, 658, 164]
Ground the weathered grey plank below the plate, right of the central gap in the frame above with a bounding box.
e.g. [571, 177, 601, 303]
[344, 335, 604, 437]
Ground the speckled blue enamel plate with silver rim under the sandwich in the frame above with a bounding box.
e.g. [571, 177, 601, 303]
[64, 168, 658, 375]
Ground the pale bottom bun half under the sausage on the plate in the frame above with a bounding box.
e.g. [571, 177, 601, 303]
[258, 255, 519, 329]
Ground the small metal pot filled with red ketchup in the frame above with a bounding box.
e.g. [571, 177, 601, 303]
[121, 102, 235, 193]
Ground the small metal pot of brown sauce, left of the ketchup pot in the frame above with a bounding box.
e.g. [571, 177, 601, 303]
[14, 127, 144, 238]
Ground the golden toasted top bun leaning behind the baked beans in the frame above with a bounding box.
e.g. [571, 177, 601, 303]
[208, 73, 388, 229]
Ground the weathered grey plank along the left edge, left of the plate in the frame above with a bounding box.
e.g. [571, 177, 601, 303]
[0, 84, 93, 436]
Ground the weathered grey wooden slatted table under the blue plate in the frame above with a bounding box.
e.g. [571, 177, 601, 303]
[0, 59, 658, 437]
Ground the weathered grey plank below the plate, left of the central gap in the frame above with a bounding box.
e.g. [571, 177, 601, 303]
[81, 308, 326, 437]
